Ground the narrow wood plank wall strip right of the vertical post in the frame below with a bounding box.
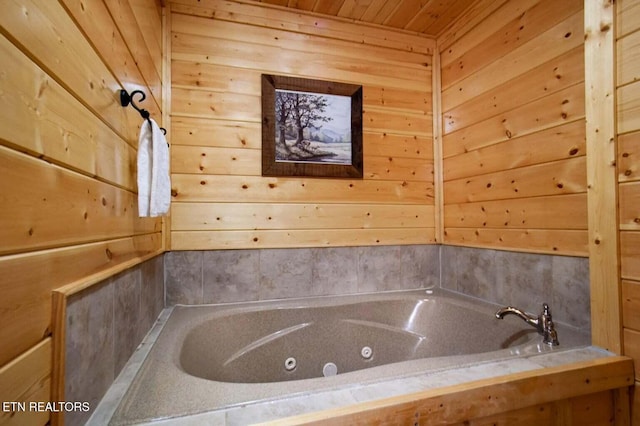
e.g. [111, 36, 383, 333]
[616, 0, 640, 418]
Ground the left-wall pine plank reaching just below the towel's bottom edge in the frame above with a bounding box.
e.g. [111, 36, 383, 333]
[0, 147, 161, 255]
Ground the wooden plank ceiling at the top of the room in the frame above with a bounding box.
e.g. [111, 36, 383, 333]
[252, 0, 474, 37]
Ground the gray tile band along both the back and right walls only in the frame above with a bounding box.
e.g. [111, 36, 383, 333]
[165, 245, 590, 330]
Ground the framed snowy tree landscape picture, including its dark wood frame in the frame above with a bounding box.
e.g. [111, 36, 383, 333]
[262, 74, 363, 178]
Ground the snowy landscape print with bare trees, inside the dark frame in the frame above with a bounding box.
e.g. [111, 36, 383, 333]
[275, 89, 352, 165]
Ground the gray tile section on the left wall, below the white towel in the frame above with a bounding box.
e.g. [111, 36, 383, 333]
[65, 256, 164, 426]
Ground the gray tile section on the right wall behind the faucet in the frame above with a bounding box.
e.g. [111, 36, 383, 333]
[441, 246, 591, 330]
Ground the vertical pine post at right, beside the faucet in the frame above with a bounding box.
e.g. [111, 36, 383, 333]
[584, 2, 623, 353]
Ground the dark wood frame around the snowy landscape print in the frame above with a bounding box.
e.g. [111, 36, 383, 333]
[262, 74, 363, 179]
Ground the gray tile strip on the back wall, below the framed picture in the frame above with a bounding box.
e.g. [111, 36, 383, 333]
[165, 245, 440, 306]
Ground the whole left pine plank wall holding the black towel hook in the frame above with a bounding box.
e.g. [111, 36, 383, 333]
[0, 0, 163, 425]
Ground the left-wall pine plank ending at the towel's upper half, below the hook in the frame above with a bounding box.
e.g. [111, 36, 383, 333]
[0, 37, 135, 190]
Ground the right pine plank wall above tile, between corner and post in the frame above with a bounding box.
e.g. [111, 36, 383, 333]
[438, 0, 588, 256]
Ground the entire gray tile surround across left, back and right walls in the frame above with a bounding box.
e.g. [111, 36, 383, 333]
[70, 245, 590, 425]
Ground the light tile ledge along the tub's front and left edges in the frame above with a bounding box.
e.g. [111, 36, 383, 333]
[87, 292, 614, 425]
